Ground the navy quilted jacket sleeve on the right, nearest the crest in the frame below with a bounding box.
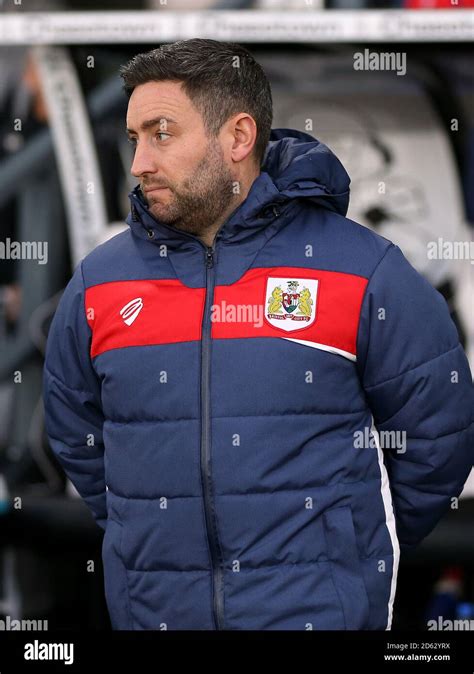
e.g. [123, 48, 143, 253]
[357, 244, 474, 548]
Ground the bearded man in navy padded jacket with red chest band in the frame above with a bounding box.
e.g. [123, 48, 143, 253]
[44, 39, 474, 630]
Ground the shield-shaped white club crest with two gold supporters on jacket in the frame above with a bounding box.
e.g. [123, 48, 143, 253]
[265, 277, 318, 332]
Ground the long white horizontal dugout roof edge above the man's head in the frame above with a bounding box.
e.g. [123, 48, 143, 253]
[0, 7, 474, 45]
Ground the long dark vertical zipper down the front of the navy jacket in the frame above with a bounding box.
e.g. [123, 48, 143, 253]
[201, 244, 224, 630]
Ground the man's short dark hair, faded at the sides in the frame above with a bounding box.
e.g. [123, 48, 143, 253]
[120, 38, 273, 166]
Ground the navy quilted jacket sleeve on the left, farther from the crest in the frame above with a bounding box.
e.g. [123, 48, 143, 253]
[43, 263, 107, 529]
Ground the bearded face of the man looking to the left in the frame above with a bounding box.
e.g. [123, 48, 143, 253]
[127, 81, 235, 236]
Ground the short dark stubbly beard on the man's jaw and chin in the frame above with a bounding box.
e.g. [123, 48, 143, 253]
[141, 142, 238, 236]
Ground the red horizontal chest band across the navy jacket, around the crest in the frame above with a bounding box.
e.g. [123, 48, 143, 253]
[85, 267, 367, 357]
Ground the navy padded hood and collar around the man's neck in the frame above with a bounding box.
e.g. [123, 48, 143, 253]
[127, 129, 350, 243]
